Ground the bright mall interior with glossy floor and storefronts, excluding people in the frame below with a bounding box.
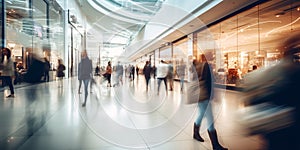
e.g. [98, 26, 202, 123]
[0, 0, 300, 150]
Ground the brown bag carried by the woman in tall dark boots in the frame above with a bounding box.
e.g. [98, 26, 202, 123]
[186, 63, 209, 104]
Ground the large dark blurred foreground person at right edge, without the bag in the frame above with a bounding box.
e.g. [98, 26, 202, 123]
[244, 33, 300, 150]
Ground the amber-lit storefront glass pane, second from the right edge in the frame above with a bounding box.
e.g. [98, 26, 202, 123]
[237, 6, 258, 75]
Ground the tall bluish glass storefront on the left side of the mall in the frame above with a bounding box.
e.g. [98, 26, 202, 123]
[3, 0, 65, 79]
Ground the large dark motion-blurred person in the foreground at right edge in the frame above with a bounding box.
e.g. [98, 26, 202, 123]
[245, 32, 300, 150]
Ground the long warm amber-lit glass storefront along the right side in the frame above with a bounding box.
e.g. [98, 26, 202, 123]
[138, 0, 300, 86]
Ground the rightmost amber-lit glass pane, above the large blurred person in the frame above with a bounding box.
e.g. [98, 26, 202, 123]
[259, 1, 300, 66]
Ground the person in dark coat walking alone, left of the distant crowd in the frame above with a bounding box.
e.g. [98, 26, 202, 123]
[78, 50, 93, 107]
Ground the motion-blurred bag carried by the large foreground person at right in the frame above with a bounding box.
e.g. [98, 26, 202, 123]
[238, 102, 295, 135]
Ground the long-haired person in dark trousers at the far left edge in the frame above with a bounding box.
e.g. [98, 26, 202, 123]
[1, 47, 15, 98]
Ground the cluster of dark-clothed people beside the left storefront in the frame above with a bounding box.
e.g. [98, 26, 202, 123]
[0, 47, 66, 98]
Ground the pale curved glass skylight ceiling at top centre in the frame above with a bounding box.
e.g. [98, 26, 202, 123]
[81, 0, 163, 48]
